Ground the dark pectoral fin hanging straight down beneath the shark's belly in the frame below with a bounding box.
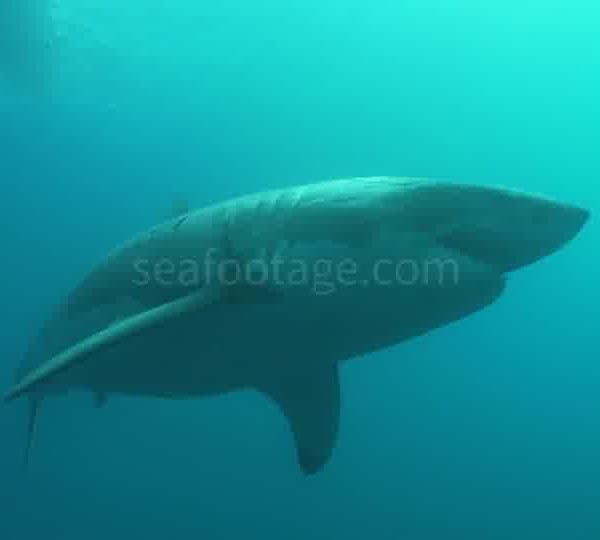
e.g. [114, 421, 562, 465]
[258, 364, 340, 474]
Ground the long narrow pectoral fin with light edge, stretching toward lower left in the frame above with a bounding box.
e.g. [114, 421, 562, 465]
[4, 286, 221, 401]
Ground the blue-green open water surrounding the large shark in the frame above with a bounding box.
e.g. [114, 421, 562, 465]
[0, 0, 600, 540]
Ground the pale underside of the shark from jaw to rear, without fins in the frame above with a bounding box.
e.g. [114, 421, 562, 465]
[38, 232, 504, 398]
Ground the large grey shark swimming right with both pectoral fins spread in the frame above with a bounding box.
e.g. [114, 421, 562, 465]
[6, 177, 589, 474]
